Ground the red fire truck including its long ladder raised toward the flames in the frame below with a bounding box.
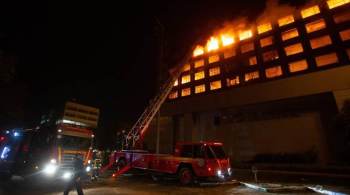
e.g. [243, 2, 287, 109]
[101, 40, 232, 185]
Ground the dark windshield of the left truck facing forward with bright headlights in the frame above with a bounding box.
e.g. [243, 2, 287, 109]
[58, 135, 91, 150]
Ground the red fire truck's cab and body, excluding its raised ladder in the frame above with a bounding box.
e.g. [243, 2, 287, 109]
[114, 142, 232, 185]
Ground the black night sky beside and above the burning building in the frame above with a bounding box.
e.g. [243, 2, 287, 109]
[0, 0, 306, 147]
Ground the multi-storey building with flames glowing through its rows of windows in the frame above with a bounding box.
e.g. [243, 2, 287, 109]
[145, 0, 350, 164]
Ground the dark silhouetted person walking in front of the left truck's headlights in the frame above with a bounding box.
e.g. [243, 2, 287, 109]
[63, 154, 85, 195]
